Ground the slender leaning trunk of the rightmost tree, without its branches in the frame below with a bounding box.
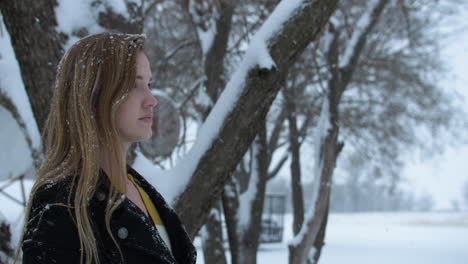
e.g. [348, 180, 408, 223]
[289, 0, 387, 263]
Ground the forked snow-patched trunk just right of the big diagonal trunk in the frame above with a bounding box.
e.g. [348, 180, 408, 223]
[223, 104, 287, 263]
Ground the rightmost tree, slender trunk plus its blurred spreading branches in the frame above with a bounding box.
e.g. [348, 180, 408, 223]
[290, 1, 459, 263]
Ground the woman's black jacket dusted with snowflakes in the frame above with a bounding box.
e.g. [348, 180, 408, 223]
[22, 167, 196, 264]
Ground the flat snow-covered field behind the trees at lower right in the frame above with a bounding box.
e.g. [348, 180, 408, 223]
[196, 212, 468, 264]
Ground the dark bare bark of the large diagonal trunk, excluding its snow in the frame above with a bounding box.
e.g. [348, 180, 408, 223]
[175, 0, 337, 237]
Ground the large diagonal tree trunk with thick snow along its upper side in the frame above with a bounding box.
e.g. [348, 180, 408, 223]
[170, 0, 336, 238]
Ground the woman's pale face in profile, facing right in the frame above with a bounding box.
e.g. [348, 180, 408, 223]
[115, 51, 157, 145]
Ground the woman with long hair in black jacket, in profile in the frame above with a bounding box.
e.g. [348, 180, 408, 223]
[17, 33, 196, 264]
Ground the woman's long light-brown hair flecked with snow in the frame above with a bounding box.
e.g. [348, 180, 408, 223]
[17, 33, 144, 263]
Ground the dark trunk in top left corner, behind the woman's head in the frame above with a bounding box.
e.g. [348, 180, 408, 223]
[0, 0, 66, 133]
